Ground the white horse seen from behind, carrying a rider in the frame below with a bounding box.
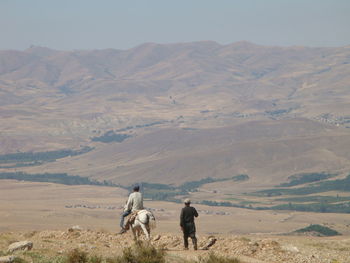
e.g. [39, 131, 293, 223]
[130, 209, 156, 240]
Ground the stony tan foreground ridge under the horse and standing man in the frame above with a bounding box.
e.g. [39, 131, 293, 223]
[0, 228, 350, 263]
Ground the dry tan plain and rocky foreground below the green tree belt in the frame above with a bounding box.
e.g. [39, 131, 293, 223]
[0, 180, 350, 263]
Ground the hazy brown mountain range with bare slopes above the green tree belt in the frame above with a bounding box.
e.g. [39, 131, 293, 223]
[0, 41, 350, 187]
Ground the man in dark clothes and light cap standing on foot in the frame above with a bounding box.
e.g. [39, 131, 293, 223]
[180, 199, 198, 250]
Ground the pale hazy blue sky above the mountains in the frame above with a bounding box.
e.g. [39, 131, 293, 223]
[0, 0, 350, 50]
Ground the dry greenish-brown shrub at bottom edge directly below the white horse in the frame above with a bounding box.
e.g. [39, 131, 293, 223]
[107, 241, 165, 263]
